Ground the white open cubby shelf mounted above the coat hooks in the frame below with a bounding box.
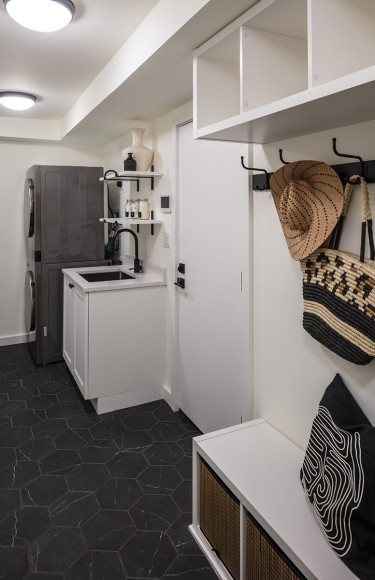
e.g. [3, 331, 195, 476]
[194, 0, 375, 143]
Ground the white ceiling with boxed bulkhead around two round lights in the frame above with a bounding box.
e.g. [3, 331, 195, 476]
[0, 0, 256, 144]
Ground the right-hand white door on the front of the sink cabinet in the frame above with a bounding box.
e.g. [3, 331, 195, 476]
[73, 290, 89, 399]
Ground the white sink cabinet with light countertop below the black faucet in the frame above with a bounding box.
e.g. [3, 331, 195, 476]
[63, 260, 165, 414]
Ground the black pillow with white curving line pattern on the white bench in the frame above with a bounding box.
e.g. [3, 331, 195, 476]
[300, 374, 375, 580]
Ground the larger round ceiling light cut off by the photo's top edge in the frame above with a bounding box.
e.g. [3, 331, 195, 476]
[3, 0, 75, 32]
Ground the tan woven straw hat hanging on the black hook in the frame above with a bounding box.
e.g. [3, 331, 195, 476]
[270, 160, 344, 260]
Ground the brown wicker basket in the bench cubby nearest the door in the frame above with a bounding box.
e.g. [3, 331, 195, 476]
[200, 459, 241, 580]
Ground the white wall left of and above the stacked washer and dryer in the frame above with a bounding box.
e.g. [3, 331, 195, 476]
[0, 140, 103, 345]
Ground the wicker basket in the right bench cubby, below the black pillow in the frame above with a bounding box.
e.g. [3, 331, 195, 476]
[246, 514, 306, 580]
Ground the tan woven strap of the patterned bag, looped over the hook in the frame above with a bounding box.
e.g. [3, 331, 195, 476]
[335, 175, 375, 262]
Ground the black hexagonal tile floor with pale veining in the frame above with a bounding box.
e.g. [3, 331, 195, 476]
[0, 344, 216, 580]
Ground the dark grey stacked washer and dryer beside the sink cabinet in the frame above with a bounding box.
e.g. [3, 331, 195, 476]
[24, 165, 107, 364]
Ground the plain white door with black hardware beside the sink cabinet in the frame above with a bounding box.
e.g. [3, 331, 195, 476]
[175, 123, 251, 432]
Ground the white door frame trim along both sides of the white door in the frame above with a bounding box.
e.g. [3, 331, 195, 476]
[172, 112, 254, 430]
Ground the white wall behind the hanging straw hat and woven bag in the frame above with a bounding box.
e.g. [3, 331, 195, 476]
[253, 121, 375, 448]
